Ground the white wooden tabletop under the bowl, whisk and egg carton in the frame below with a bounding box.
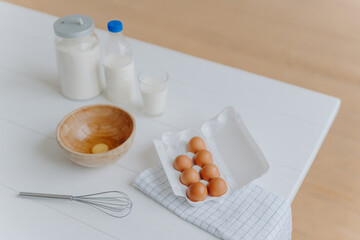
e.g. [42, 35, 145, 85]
[0, 2, 340, 240]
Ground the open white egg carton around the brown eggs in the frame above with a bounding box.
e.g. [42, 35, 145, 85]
[154, 107, 269, 206]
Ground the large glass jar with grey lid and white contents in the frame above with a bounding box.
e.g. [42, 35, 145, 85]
[54, 15, 102, 100]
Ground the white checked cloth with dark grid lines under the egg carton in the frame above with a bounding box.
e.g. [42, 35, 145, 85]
[134, 167, 292, 240]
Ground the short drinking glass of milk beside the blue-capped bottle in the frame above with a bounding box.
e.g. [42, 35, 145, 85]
[138, 69, 169, 116]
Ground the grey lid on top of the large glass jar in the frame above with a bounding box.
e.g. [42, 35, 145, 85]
[54, 14, 95, 38]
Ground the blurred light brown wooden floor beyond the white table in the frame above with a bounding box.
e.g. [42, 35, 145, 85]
[4, 0, 360, 240]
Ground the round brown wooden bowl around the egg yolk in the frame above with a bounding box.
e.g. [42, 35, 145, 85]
[56, 104, 135, 167]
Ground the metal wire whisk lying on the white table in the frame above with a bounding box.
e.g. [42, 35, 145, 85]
[19, 191, 133, 218]
